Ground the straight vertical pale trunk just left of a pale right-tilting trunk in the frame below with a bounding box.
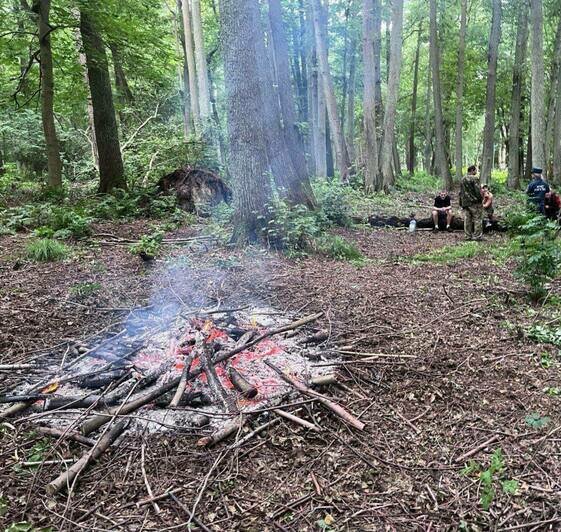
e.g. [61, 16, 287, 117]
[362, 0, 381, 192]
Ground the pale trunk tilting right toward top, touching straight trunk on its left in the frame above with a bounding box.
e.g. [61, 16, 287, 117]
[380, 0, 403, 190]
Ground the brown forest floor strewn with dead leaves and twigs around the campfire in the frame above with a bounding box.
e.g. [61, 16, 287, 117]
[0, 202, 561, 531]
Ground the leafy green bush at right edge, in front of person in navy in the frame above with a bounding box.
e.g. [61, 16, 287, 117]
[512, 215, 561, 300]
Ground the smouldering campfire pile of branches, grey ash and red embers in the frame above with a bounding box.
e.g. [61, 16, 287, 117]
[0, 309, 364, 495]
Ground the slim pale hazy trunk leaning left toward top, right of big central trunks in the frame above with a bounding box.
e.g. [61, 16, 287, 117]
[312, 0, 350, 182]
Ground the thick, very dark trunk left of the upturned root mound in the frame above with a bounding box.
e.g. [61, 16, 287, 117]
[80, 11, 127, 193]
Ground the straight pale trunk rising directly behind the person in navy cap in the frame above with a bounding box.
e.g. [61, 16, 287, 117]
[530, 0, 546, 177]
